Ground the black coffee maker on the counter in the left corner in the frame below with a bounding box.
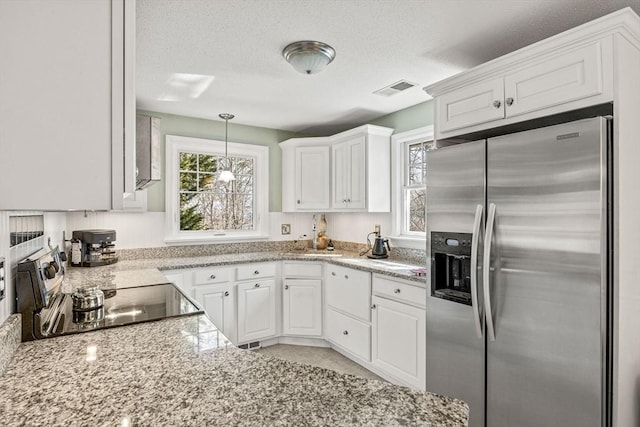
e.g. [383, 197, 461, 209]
[71, 230, 118, 267]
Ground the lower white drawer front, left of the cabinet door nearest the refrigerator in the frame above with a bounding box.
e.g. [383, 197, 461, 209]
[326, 309, 371, 361]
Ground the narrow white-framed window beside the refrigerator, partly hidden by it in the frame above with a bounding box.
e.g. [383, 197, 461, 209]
[392, 126, 433, 249]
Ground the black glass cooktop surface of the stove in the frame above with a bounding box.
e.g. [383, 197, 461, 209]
[54, 283, 203, 336]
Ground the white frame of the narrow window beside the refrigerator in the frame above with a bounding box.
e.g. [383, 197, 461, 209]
[391, 125, 434, 250]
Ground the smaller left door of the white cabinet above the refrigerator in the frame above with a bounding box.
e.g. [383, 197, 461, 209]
[436, 77, 504, 133]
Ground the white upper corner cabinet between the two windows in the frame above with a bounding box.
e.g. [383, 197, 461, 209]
[280, 125, 393, 212]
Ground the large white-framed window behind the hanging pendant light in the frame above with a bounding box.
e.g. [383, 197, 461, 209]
[166, 135, 269, 243]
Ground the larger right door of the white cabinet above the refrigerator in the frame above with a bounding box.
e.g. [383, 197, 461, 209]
[504, 42, 603, 117]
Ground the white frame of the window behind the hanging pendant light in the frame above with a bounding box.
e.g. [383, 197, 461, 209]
[165, 135, 269, 245]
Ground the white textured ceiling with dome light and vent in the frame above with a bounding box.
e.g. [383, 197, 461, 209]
[136, 0, 640, 135]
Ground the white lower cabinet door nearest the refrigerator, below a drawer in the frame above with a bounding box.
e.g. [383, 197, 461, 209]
[371, 296, 427, 390]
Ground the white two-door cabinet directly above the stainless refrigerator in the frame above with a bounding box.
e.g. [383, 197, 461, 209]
[425, 27, 613, 139]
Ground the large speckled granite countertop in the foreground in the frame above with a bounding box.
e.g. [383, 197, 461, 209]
[0, 315, 468, 427]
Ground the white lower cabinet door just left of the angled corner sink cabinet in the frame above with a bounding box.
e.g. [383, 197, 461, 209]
[238, 280, 276, 343]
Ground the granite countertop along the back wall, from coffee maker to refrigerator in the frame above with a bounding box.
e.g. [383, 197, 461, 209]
[63, 251, 426, 292]
